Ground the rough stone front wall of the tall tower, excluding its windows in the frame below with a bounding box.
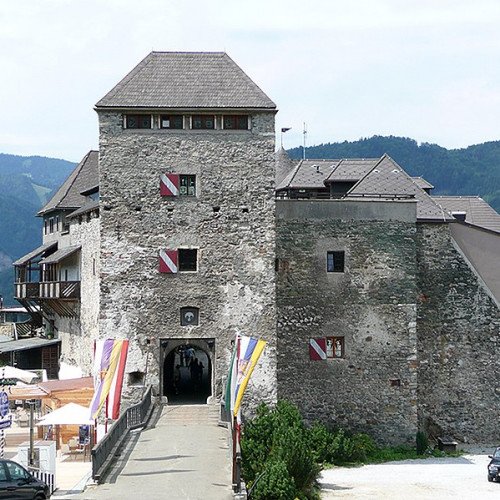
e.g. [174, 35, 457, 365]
[99, 112, 276, 408]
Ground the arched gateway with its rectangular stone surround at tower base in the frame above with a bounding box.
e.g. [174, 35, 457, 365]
[160, 339, 214, 404]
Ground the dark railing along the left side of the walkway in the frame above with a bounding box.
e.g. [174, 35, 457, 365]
[92, 386, 153, 481]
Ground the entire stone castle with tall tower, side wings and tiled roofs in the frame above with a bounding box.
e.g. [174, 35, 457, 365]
[15, 52, 500, 443]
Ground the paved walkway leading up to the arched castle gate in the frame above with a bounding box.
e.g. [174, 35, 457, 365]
[72, 405, 232, 500]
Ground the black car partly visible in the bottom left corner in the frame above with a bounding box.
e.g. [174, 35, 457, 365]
[0, 460, 50, 500]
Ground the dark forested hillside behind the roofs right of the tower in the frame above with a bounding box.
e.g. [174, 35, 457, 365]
[288, 136, 500, 212]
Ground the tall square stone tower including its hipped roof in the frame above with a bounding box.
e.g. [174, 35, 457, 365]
[95, 52, 276, 410]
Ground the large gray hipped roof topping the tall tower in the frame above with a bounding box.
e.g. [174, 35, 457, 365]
[96, 52, 276, 109]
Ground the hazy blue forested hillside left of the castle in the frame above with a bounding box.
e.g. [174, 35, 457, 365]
[0, 154, 75, 305]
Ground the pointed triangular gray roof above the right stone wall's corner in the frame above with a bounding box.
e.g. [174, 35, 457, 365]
[348, 155, 453, 221]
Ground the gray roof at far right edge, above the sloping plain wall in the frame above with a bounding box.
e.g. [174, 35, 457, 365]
[432, 196, 500, 233]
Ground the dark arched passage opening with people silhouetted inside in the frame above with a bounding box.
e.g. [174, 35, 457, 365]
[163, 344, 212, 404]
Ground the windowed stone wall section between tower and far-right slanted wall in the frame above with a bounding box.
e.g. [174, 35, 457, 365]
[276, 200, 417, 443]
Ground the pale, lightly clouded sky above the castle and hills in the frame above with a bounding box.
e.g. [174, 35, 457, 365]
[0, 0, 500, 161]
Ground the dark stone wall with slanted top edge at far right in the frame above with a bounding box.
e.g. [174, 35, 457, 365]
[417, 224, 500, 443]
